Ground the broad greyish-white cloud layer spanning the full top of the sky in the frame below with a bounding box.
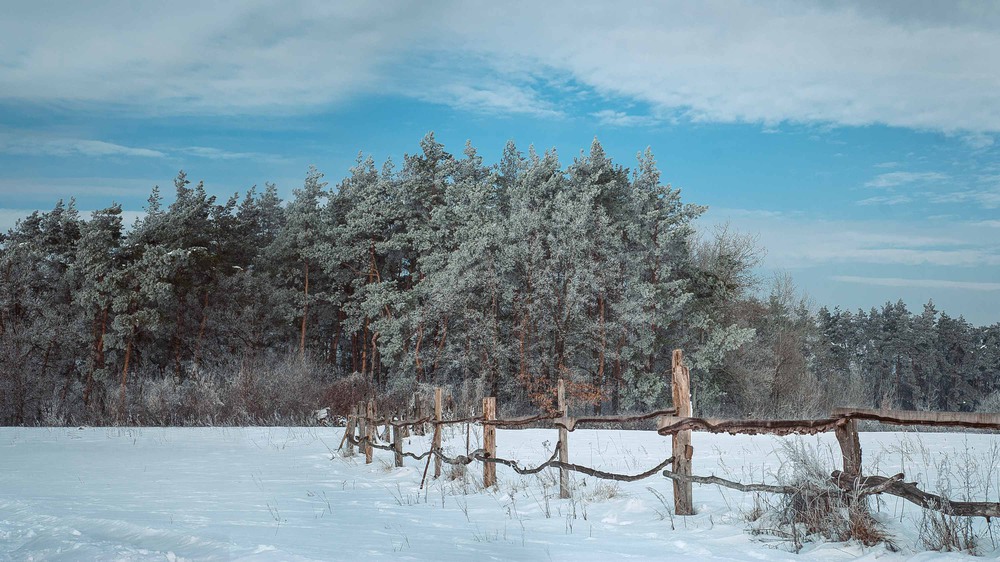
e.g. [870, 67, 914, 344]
[0, 0, 1000, 130]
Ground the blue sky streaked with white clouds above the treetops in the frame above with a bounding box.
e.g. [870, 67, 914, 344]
[0, 0, 1000, 325]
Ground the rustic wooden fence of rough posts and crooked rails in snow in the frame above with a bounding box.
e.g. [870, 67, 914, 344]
[341, 350, 1000, 517]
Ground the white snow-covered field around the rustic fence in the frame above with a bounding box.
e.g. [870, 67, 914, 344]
[0, 427, 1000, 561]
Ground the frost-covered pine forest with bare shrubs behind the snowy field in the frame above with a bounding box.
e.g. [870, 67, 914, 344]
[0, 134, 1000, 425]
